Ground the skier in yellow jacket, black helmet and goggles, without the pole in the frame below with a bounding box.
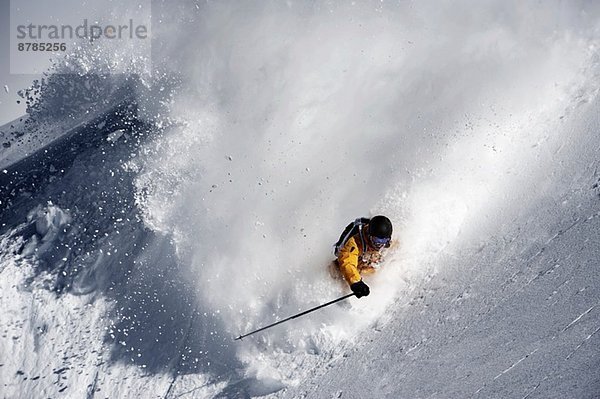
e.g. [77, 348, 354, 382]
[334, 215, 392, 298]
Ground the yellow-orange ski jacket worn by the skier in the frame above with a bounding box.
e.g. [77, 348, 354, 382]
[337, 234, 381, 285]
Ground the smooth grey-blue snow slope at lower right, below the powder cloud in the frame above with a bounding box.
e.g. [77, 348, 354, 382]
[277, 97, 600, 398]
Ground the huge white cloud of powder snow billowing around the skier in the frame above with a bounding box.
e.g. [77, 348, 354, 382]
[127, 2, 598, 394]
